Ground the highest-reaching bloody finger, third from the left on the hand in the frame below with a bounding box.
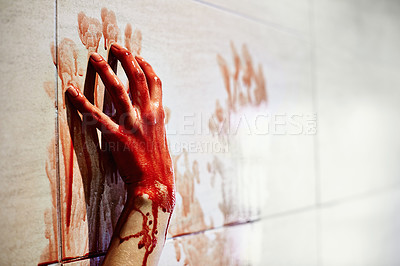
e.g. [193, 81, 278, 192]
[110, 44, 150, 110]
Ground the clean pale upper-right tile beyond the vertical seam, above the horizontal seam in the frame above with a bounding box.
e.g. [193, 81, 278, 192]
[314, 1, 400, 202]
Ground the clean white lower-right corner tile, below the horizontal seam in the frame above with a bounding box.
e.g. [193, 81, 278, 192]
[320, 189, 400, 266]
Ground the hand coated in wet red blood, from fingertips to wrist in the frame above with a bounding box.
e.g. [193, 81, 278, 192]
[67, 44, 175, 212]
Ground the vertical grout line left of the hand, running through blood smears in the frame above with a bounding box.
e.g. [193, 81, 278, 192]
[54, 0, 63, 263]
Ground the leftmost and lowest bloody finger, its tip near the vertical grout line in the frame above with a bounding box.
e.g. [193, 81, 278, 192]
[67, 86, 118, 133]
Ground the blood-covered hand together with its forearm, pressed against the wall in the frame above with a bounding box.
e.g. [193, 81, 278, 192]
[67, 44, 175, 265]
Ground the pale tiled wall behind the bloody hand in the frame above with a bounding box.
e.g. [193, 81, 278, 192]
[0, 0, 400, 266]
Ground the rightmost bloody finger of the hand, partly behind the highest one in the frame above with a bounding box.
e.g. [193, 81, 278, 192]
[135, 56, 162, 104]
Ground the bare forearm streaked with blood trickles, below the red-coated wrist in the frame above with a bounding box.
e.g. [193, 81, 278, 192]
[104, 190, 171, 265]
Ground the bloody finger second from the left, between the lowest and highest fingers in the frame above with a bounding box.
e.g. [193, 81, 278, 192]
[90, 53, 132, 118]
